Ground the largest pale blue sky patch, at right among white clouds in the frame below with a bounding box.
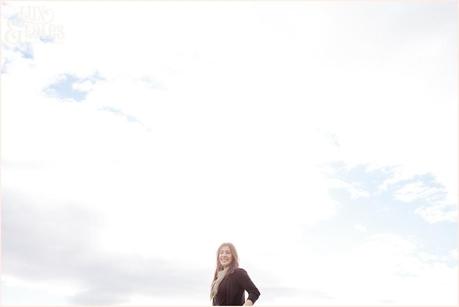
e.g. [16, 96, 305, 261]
[320, 163, 458, 265]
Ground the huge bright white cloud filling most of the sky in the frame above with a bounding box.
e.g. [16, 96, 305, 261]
[1, 2, 457, 305]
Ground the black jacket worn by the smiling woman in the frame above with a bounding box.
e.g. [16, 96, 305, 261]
[212, 268, 260, 306]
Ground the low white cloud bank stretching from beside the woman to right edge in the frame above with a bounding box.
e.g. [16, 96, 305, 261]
[253, 233, 457, 305]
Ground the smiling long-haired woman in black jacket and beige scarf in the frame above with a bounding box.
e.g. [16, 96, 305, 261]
[210, 243, 260, 306]
